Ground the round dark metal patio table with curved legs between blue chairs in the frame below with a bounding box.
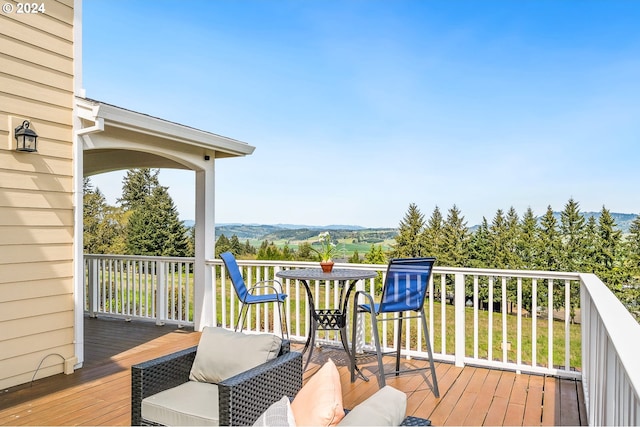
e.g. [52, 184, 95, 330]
[276, 268, 377, 370]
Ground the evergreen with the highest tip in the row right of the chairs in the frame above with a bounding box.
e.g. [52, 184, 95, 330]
[560, 198, 584, 271]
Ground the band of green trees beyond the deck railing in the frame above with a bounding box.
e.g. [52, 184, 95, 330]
[83, 169, 640, 318]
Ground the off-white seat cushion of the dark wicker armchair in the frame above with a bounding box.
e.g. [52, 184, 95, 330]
[142, 381, 220, 426]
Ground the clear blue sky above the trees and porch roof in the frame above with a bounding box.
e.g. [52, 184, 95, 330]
[83, 0, 640, 227]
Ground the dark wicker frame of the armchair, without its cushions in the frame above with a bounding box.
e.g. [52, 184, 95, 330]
[131, 340, 302, 426]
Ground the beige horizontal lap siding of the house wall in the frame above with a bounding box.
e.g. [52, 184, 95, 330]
[0, 0, 76, 390]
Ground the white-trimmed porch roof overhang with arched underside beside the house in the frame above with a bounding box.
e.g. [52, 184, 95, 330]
[76, 97, 255, 176]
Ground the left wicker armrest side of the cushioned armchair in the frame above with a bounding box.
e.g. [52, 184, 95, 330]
[131, 347, 197, 426]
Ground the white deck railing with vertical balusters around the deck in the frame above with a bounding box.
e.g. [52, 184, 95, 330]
[85, 255, 640, 425]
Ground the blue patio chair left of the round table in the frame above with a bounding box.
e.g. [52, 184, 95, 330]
[220, 252, 289, 339]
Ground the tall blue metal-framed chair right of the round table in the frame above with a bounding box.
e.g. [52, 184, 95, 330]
[350, 258, 440, 397]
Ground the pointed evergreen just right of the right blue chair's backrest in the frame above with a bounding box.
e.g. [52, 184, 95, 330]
[439, 205, 469, 267]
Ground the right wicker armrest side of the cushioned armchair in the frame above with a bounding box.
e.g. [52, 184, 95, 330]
[218, 352, 302, 426]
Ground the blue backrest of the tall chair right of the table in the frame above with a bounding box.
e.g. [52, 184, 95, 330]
[379, 257, 436, 313]
